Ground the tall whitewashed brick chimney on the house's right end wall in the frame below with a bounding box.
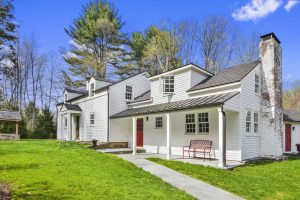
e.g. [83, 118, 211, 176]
[260, 33, 283, 157]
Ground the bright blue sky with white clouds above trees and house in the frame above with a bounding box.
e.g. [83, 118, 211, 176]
[14, 0, 300, 85]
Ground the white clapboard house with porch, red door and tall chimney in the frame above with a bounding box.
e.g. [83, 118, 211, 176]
[57, 33, 300, 166]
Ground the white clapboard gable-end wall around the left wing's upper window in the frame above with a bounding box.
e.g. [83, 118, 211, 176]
[109, 73, 150, 115]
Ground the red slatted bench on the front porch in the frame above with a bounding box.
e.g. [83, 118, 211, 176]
[182, 140, 212, 159]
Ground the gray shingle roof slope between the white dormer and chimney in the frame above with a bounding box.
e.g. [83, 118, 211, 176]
[188, 60, 260, 92]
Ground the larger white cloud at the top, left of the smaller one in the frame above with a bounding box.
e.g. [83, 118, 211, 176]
[232, 0, 282, 21]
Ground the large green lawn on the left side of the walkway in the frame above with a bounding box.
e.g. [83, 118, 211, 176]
[0, 140, 192, 199]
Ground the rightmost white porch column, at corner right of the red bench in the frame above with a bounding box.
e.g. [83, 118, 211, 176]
[218, 106, 226, 167]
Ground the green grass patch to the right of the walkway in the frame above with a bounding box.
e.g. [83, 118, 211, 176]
[149, 158, 300, 199]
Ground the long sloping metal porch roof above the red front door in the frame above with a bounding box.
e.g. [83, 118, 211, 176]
[110, 92, 239, 118]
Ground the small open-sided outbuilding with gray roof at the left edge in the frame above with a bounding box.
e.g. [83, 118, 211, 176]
[0, 110, 22, 140]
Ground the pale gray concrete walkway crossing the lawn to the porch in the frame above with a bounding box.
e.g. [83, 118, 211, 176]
[119, 154, 242, 200]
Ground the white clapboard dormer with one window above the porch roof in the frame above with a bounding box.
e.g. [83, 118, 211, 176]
[149, 64, 213, 104]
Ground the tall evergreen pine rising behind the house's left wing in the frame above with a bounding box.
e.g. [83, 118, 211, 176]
[64, 0, 126, 79]
